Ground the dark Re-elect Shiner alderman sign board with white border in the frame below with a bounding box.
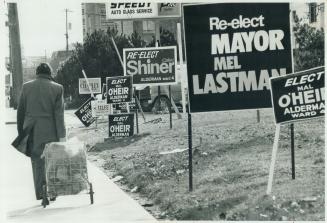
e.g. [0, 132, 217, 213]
[124, 46, 177, 85]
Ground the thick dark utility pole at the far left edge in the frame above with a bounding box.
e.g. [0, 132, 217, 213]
[7, 3, 23, 109]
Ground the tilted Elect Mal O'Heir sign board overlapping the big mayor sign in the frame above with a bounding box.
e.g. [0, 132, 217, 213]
[271, 67, 325, 123]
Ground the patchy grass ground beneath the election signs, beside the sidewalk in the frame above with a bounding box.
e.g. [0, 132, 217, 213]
[70, 109, 325, 221]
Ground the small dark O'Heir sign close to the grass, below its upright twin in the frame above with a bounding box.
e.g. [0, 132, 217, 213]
[109, 114, 134, 137]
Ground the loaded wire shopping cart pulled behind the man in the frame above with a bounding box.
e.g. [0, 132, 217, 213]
[42, 138, 94, 207]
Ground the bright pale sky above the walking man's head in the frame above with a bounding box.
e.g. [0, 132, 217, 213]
[11, 0, 83, 57]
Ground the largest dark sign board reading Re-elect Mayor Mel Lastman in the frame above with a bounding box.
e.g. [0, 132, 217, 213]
[184, 3, 292, 112]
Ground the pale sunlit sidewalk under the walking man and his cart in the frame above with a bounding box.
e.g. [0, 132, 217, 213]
[0, 109, 156, 223]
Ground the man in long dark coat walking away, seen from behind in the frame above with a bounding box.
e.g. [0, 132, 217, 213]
[17, 63, 66, 203]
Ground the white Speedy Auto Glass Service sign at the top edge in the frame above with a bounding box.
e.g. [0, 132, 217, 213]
[106, 1, 181, 20]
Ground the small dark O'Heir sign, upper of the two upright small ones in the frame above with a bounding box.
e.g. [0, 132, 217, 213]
[106, 76, 133, 104]
